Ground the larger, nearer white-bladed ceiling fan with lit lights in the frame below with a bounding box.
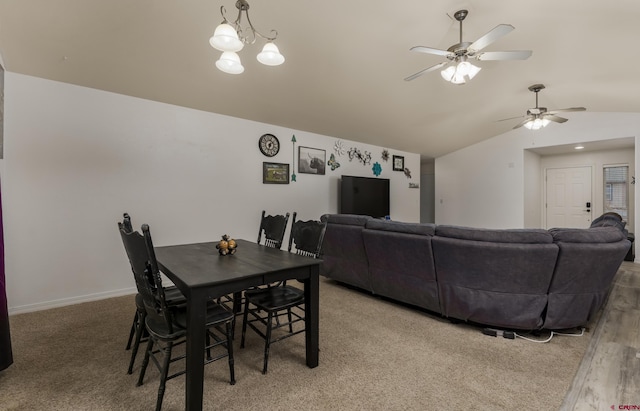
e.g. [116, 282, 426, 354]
[405, 10, 531, 84]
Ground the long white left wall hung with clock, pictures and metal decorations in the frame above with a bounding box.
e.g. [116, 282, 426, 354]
[2, 73, 420, 313]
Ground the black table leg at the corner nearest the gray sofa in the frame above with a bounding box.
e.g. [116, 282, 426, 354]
[304, 265, 320, 368]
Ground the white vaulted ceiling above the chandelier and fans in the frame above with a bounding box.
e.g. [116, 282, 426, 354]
[0, 0, 640, 159]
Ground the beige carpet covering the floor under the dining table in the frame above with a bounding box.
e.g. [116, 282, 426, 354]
[0, 278, 590, 411]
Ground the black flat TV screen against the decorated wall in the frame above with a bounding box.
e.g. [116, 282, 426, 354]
[340, 176, 389, 218]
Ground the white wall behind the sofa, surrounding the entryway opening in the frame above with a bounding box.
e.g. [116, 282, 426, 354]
[435, 112, 640, 232]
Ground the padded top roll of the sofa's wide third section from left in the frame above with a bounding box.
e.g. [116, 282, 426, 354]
[436, 225, 553, 244]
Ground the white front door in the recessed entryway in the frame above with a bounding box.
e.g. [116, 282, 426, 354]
[545, 166, 592, 232]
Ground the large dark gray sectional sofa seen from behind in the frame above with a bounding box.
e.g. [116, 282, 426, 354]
[321, 214, 631, 330]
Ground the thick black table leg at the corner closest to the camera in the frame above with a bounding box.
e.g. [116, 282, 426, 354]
[185, 290, 207, 411]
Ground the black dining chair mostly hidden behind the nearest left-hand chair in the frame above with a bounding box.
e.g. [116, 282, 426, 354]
[118, 213, 186, 374]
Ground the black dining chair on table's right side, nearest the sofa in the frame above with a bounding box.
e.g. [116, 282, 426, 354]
[240, 212, 327, 374]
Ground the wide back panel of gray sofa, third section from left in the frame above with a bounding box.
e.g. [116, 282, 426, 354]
[432, 226, 558, 329]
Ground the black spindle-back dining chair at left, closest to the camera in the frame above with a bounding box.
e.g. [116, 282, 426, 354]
[120, 224, 235, 411]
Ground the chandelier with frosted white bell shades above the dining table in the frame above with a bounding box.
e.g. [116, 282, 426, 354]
[209, 0, 284, 74]
